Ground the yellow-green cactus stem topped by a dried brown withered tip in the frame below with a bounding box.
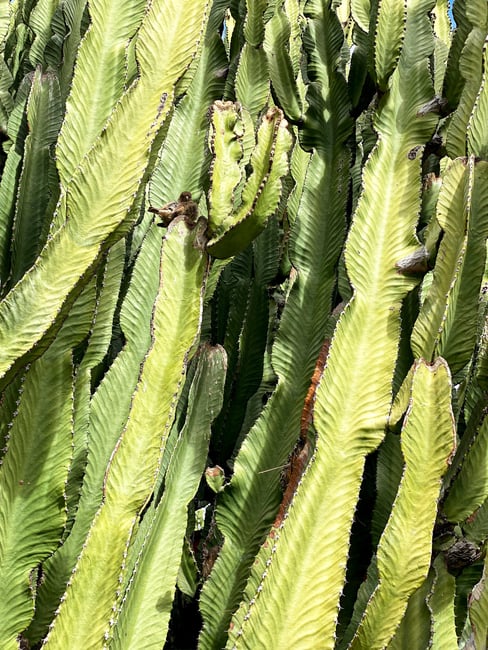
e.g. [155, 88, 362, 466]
[44, 217, 207, 648]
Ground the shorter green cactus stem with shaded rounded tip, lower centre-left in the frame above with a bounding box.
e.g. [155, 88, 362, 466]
[111, 345, 226, 650]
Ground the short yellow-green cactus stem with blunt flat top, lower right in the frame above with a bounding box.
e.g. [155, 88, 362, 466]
[350, 359, 455, 650]
